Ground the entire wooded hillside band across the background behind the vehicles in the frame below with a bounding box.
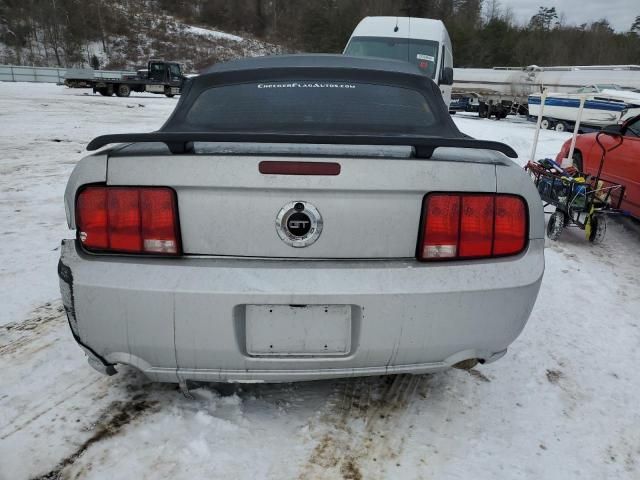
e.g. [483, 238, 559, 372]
[0, 0, 640, 70]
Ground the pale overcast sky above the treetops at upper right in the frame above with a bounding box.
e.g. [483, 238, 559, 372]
[500, 0, 640, 32]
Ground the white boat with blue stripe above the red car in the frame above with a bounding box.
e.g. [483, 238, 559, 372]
[528, 84, 640, 131]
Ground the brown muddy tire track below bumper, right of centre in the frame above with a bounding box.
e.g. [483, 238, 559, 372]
[298, 374, 429, 480]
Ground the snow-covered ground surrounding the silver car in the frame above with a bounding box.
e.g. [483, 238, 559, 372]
[0, 83, 640, 480]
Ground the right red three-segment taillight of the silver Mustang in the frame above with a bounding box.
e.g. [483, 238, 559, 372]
[418, 193, 528, 260]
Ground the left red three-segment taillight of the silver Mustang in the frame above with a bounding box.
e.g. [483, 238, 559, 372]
[76, 186, 180, 255]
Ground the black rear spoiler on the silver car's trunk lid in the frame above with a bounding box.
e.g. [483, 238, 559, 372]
[87, 132, 518, 158]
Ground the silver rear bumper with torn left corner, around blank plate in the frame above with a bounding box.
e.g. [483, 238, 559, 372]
[60, 239, 544, 382]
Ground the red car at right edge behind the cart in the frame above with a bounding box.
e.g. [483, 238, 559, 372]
[556, 115, 640, 219]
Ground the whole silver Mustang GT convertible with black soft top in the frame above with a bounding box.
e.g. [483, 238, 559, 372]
[58, 55, 544, 384]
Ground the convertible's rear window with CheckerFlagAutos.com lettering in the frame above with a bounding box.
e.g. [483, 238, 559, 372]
[185, 80, 436, 135]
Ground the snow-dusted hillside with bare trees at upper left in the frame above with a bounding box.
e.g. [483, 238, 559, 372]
[0, 0, 283, 71]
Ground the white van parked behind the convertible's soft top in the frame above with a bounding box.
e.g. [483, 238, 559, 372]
[343, 17, 453, 105]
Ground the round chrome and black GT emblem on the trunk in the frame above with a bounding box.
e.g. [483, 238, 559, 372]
[276, 201, 322, 248]
